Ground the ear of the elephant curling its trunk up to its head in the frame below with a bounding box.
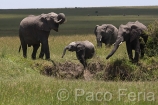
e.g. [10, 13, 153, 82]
[38, 14, 51, 31]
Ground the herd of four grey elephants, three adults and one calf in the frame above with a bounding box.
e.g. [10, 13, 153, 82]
[19, 12, 148, 68]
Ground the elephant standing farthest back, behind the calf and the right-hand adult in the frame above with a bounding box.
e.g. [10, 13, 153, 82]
[94, 24, 118, 47]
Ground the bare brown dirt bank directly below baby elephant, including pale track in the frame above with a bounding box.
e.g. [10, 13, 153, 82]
[36, 61, 105, 80]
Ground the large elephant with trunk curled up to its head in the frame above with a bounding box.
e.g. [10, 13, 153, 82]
[19, 12, 66, 59]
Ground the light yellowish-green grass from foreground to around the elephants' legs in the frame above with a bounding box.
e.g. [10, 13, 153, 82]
[0, 35, 158, 105]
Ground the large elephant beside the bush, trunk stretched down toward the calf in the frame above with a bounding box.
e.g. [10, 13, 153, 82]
[106, 21, 148, 62]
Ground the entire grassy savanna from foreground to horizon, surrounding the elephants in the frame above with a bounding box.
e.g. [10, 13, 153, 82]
[0, 6, 158, 105]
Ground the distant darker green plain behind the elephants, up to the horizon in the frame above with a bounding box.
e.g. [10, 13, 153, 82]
[0, 7, 158, 36]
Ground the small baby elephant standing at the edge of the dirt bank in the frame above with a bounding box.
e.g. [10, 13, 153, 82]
[62, 41, 95, 68]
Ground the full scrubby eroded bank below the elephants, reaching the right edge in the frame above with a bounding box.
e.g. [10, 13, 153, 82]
[32, 59, 158, 81]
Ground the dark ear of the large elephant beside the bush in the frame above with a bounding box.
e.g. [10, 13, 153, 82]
[130, 25, 140, 42]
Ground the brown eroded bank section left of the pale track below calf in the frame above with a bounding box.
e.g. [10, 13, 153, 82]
[32, 61, 84, 79]
